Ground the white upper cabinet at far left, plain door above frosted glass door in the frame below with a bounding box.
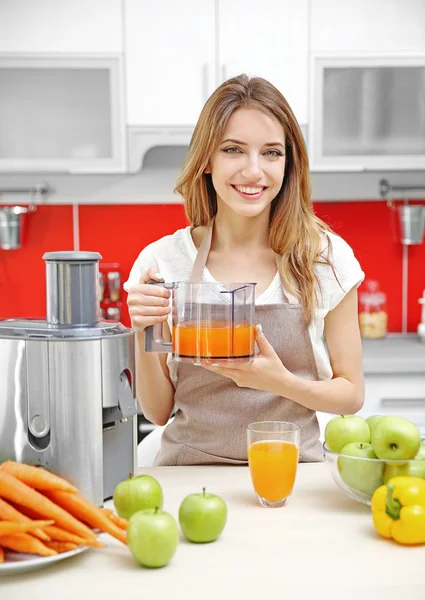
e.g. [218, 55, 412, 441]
[0, 0, 127, 173]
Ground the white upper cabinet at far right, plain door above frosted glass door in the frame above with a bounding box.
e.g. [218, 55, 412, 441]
[308, 0, 425, 171]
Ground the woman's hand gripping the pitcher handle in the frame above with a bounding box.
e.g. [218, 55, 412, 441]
[127, 267, 170, 332]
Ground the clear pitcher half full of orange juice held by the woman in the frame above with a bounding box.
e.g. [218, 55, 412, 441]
[145, 281, 256, 364]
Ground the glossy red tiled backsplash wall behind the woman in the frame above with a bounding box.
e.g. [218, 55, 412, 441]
[0, 202, 425, 332]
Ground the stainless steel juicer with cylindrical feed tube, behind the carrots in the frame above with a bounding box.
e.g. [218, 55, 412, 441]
[0, 252, 137, 505]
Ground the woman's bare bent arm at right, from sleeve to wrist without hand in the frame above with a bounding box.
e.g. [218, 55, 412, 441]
[280, 288, 364, 414]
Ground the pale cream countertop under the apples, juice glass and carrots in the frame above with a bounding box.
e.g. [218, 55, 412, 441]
[0, 463, 425, 600]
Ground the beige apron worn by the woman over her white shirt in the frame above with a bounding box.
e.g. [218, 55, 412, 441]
[154, 224, 323, 466]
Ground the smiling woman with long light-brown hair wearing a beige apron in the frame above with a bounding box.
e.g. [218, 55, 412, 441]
[125, 75, 364, 465]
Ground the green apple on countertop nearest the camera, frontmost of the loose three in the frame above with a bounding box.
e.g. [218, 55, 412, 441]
[127, 508, 180, 569]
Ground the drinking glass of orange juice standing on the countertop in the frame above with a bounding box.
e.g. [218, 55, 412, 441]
[247, 421, 300, 507]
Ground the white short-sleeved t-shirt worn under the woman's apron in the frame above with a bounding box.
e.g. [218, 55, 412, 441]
[124, 226, 365, 385]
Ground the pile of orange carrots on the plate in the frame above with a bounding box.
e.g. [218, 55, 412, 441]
[0, 461, 128, 563]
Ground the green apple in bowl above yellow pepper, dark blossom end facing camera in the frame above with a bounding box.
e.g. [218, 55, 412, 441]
[371, 416, 421, 460]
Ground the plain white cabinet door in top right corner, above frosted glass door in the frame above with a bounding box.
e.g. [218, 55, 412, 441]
[311, 0, 425, 56]
